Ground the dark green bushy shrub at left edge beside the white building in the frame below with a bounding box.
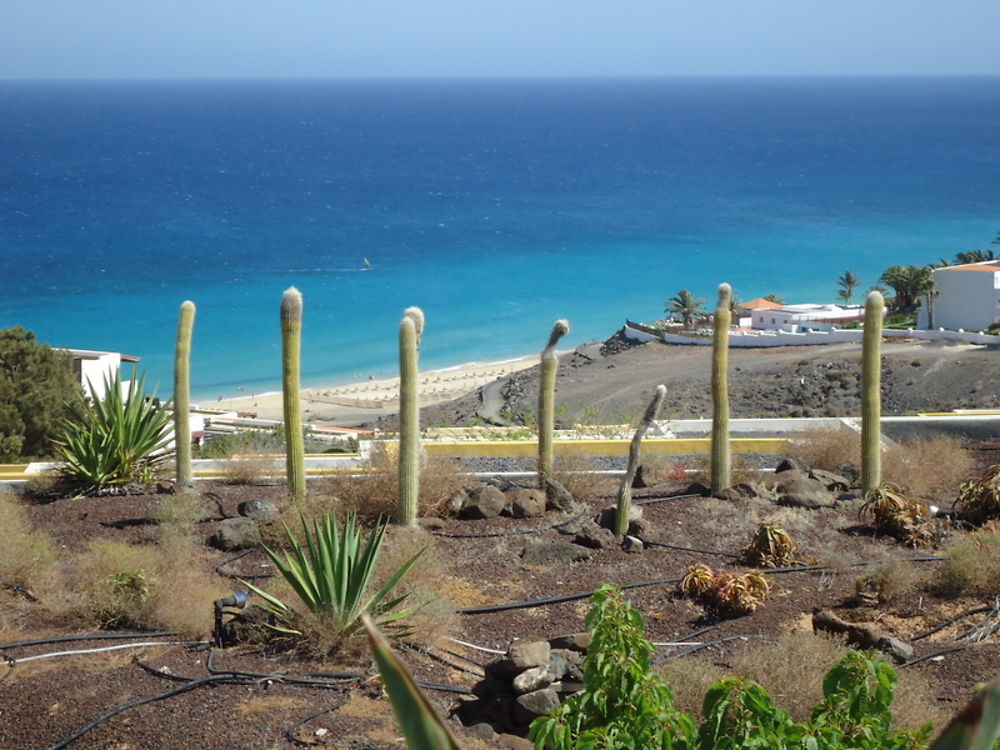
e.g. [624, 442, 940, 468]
[0, 326, 83, 461]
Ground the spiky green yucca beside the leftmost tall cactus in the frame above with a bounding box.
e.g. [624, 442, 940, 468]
[53, 373, 171, 494]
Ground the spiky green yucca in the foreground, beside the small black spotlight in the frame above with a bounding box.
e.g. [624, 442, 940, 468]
[244, 513, 423, 636]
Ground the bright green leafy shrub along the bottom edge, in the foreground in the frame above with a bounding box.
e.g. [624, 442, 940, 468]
[529, 584, 931, 750]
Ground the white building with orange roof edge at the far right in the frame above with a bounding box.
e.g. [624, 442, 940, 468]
[917, 260, 1000, 331]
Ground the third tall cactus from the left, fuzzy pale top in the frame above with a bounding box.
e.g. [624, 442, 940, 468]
[396, 307, 424, 526]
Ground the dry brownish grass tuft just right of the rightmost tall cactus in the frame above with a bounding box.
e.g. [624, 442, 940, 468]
[882, 437, 974, 500]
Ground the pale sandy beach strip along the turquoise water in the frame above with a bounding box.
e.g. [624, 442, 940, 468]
[204, 354, 538, 426]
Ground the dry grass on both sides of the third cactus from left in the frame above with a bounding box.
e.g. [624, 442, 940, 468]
[324, 445, 466, 520]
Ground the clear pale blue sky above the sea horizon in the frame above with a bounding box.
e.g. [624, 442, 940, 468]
[0, 0, 1000, 78]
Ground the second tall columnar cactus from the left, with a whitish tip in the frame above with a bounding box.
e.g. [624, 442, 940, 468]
[281, 287, 306, 503]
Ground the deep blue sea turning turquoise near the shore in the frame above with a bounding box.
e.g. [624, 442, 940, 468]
[0, 78, 1000, 398]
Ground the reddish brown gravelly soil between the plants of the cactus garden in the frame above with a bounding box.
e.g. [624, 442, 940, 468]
[0, 446, 1000, 750]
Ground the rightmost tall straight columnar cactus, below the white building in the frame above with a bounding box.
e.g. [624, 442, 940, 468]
[861, 292, 885, 494]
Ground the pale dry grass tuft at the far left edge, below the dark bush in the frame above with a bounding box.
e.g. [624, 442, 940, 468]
[0, 492, 58, 596]
